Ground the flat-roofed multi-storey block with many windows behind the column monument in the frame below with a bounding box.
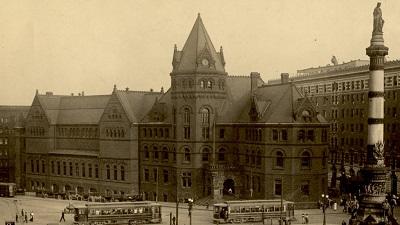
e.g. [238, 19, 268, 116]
[268, 57, 400, 190]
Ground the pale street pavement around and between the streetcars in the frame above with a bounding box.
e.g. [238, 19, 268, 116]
[0, 196, 349, 225]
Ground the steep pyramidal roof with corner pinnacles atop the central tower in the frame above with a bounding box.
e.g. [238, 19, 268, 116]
[172, 14, 225, 74]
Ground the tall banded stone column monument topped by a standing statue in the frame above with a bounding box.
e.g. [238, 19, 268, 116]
[349, 3, 388, 225]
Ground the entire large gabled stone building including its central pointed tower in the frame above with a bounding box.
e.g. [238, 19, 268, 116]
[22, 15, 329, 202]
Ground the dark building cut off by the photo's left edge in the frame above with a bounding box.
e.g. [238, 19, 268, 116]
[0, 106, 29, 188]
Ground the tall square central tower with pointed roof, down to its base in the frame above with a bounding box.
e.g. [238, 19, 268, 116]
[170, 14, 227, 198]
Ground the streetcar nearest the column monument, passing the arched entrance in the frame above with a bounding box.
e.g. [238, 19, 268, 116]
[213, 199, 294, 224]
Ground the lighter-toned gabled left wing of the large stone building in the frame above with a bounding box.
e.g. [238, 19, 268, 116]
[26, 87, 160, 196]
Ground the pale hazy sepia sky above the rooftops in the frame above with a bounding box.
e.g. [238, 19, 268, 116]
[0, 0, 400, 105]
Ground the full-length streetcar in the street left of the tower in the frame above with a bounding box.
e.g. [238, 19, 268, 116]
[73, 201, 161, 225]
